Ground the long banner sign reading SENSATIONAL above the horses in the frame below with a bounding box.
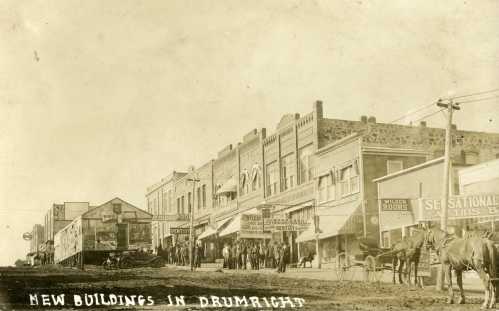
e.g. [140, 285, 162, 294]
[419, 194, 499, 221]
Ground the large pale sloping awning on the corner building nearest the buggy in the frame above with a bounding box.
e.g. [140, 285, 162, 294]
[296, 201, 362, 243]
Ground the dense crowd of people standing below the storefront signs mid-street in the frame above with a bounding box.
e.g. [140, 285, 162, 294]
[222, 240, 290, 272]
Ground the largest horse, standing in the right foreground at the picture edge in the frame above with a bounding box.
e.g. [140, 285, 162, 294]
[425, 228, 497, 309]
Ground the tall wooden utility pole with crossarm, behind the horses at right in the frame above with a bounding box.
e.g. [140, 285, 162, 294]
[437, 99, 461, 290]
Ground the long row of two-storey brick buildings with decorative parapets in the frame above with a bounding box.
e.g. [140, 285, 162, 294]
[148, 101, 499, 266]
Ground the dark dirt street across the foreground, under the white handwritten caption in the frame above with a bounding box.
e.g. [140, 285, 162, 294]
[0, 267, 492, 311]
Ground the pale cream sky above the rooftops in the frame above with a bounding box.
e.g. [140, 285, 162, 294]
[0, 0, 499, 265]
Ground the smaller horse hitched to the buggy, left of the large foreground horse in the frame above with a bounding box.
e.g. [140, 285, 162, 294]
[385, 230, 425, 284]
